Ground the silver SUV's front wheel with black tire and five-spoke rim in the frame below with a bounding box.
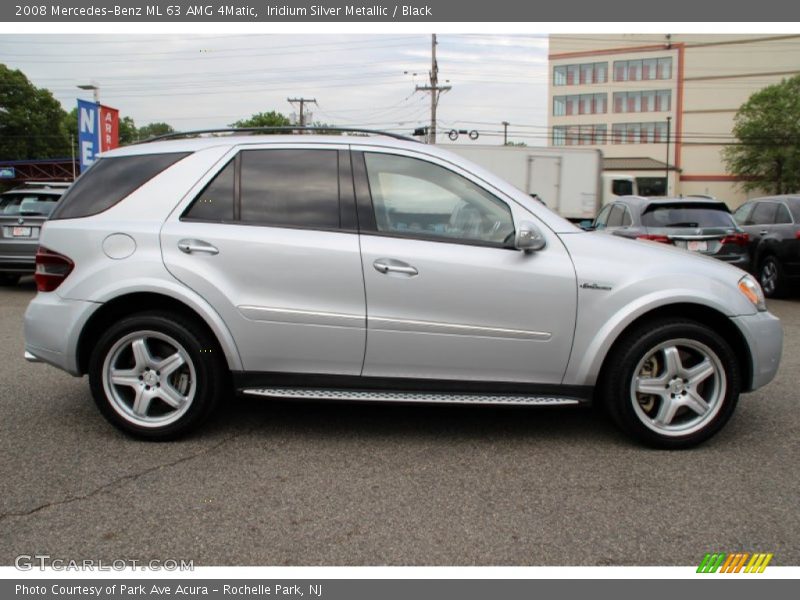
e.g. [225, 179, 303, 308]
[600, 319, 741, 449]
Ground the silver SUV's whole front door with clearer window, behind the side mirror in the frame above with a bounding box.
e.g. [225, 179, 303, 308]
[353, 147, 577, 384]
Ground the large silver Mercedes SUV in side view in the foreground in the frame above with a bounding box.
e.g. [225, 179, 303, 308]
[25, 132, 783, 448]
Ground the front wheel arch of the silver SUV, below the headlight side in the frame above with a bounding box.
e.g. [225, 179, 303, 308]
[595, 302, 753, 390]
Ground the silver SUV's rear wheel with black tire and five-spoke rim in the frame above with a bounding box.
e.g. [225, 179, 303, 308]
[89, 311, 229, 441]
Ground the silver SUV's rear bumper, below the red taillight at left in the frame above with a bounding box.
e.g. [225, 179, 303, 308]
[24, 292, 101, 376]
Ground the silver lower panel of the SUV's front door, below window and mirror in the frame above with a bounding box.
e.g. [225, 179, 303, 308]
[361, 235, 576, 383]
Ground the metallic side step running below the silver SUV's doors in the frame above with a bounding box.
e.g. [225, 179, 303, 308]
[241, 387, 581, 406]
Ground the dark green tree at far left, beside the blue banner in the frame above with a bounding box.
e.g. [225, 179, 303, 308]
[0, 64, 70, 160]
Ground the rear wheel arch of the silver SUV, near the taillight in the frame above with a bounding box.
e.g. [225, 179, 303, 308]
[77, 291, 241, 375]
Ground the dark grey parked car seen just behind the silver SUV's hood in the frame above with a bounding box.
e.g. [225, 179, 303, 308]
[593, 196, 750, 270]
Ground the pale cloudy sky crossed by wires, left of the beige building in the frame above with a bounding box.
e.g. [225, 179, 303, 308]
[0, 33, 547, 145]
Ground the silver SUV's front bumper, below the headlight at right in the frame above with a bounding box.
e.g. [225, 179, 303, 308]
[732, 312, 783, 392]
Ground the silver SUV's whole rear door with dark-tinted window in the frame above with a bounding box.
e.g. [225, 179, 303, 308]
[161, 144, 366, 375]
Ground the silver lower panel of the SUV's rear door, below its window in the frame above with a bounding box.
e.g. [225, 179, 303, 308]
[161, 221, 366, 375]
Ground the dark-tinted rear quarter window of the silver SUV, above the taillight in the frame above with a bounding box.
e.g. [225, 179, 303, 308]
[50, 152, 190, 220]
